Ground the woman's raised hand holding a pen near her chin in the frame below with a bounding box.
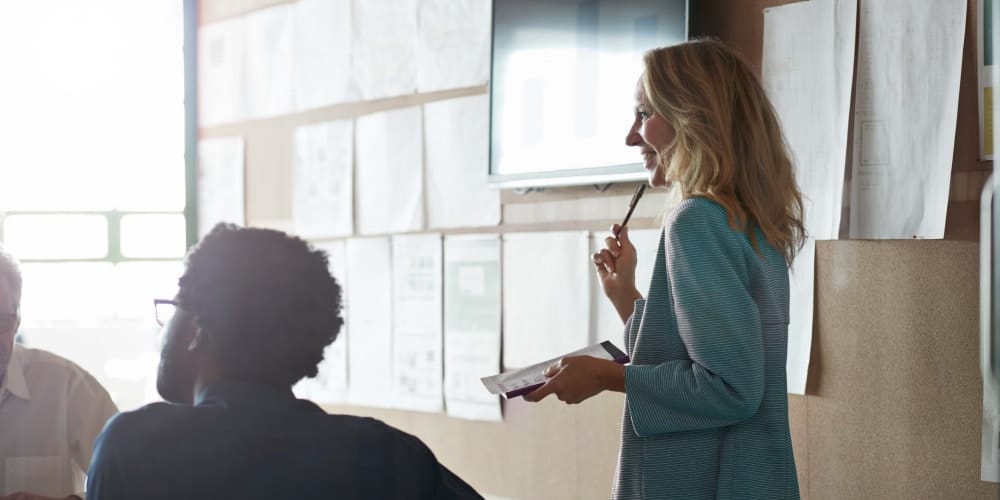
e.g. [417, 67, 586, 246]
[591, 224, 642, 322]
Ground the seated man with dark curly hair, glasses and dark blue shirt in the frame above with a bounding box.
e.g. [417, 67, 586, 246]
[87, 224, 479, 500]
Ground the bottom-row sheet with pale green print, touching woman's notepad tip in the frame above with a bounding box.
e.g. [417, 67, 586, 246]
[444, 234, 503, 422]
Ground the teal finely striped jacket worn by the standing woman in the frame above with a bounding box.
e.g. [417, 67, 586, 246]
[613, 198, 799, 500]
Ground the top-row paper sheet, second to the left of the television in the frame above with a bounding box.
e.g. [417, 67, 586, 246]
[351, 0, 417, 100]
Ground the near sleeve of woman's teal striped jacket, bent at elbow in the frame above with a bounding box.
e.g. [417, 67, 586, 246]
[625, 200, 764, 436]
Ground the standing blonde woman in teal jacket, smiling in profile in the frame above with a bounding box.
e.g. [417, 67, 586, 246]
[525, 40, 805, 499]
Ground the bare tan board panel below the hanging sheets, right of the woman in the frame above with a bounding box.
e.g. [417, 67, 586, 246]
[806, 241, 998, 500]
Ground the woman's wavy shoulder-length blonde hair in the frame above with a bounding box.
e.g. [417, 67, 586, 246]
[642, 39, 805, 266]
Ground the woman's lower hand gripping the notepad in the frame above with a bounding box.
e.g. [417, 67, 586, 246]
[524, 356, 625, 404]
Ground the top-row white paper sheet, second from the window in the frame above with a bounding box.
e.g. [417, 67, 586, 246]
[244, 5, 295, 118]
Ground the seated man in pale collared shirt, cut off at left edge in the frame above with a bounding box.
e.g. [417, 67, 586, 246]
[0, 244, 118, 500]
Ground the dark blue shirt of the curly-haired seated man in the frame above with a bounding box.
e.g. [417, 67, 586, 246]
[87, 384, 481, 500]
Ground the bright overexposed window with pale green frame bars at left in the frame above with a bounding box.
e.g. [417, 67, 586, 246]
[0, 0, 195, 409]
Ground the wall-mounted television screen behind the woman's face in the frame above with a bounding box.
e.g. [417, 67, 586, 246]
[489, 0, 688, 187]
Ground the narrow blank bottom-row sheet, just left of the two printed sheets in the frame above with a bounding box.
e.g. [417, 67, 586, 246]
[345, 238, 395, 408]
